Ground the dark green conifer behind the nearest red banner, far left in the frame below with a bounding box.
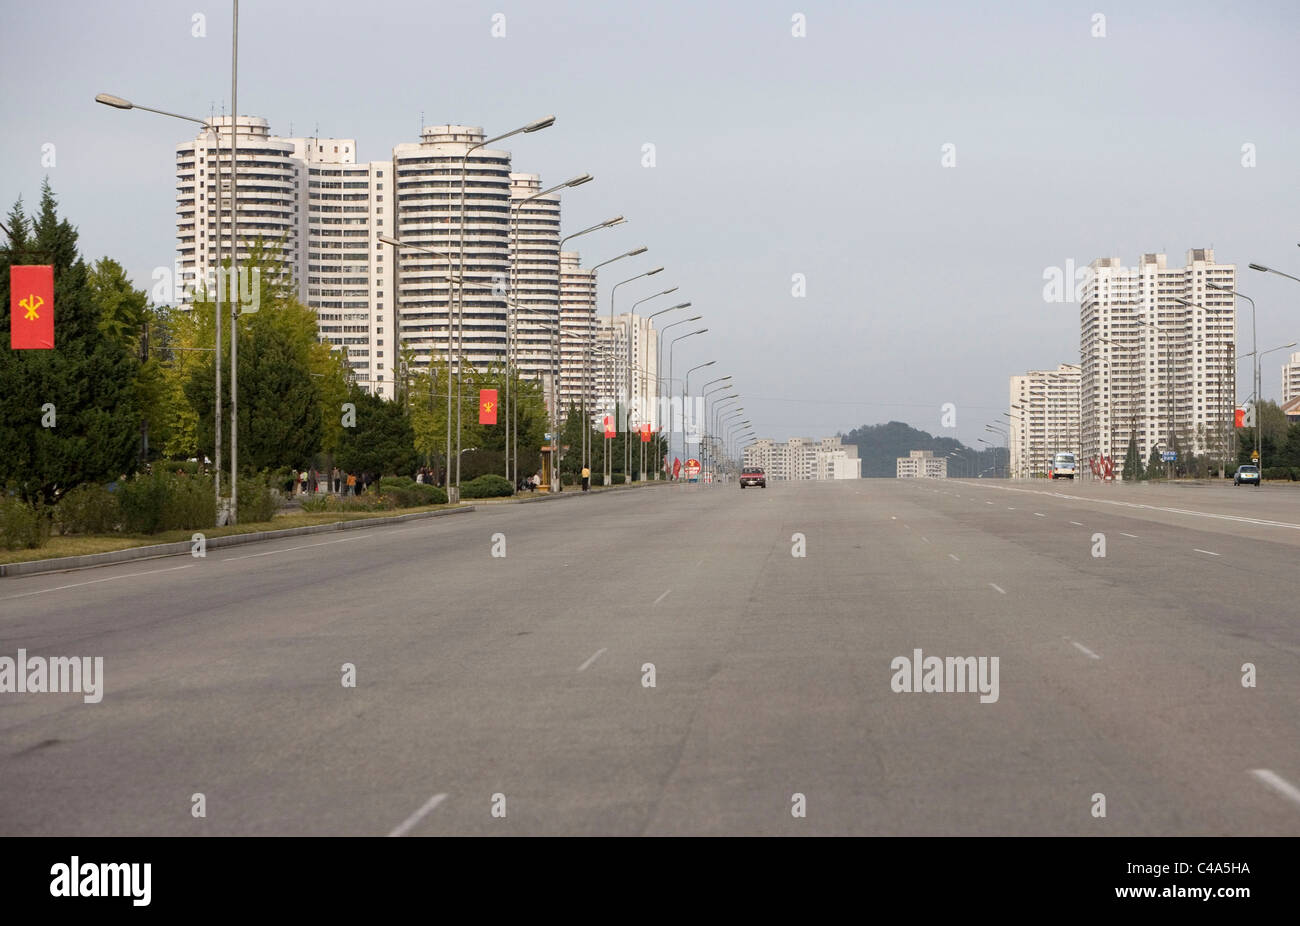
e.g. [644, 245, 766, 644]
[0, 181, 140, 502]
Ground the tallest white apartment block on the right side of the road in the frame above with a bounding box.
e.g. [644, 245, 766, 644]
[1079, 248, 1236, 473]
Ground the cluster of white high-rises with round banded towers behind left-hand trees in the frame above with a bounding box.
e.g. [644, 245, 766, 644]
[177, 116, 600, 408]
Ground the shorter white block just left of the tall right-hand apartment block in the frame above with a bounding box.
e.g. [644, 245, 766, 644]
[1008, 363, 1083, 479]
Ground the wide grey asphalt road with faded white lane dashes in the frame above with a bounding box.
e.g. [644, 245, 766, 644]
[0, 480, 1300, 836]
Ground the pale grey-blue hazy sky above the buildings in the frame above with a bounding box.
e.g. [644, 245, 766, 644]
[0, 0, 1300, 443]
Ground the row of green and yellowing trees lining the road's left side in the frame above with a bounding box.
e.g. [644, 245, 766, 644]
[0, 182, 644, 505]
